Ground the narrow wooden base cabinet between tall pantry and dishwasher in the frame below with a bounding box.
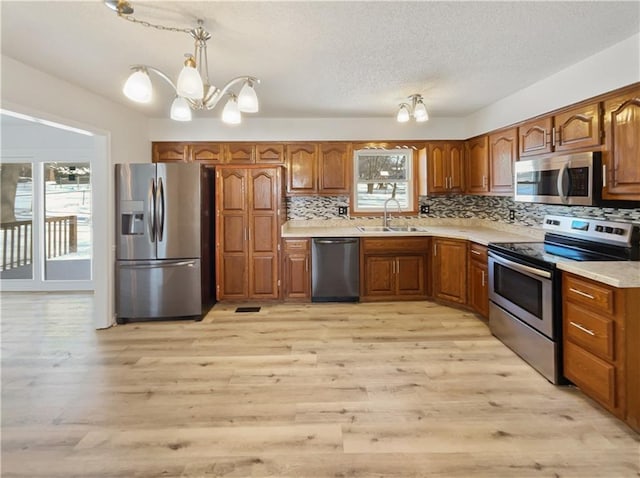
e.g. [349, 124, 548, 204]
[283, 239, 311, 301]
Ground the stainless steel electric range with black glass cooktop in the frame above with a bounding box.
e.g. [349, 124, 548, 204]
[489, 215, 640, 384]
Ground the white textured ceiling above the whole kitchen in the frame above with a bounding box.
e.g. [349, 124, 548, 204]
[0, 0, 640, 118]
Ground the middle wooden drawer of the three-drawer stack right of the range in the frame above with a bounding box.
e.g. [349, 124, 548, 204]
[564, 302, 615, 361]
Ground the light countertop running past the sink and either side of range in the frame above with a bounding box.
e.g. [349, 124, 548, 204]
[282, 218, 640, 288]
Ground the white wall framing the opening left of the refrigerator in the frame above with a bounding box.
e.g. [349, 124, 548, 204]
[1, 56, 151, 327]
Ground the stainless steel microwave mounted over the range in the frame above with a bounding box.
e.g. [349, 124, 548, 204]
[514, 151, 602, 206]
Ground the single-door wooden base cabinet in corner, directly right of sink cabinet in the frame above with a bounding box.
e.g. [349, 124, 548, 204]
[432, 238, 467, 304]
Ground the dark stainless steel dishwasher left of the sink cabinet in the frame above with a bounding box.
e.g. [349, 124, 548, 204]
[311, 237, 360, 302]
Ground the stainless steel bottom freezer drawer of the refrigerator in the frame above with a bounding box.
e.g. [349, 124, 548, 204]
[116, 259, 202, 323]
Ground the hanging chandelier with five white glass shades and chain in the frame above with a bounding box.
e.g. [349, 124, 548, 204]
[104, 0, 260, 124]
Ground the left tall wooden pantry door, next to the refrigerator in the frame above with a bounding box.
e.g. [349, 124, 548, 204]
[216, 169, 249, 299]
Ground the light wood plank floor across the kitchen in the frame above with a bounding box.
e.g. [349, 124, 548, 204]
[1, 293, 640, 478]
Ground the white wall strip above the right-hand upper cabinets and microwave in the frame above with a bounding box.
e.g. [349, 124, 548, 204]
[465, 33, 640, 137]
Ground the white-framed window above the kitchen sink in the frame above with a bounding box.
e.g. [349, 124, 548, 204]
[352, 148, 417, 215]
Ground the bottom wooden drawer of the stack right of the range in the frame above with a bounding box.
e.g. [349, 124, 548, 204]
[564, 341, 616, 410]
